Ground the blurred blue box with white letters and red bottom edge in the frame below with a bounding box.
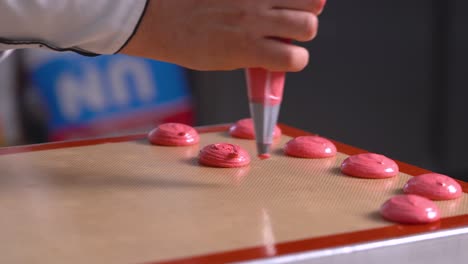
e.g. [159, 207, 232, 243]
[27, 51, 193, 140]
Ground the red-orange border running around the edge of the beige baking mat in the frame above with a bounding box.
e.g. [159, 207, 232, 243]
[0, 124, 468, 264]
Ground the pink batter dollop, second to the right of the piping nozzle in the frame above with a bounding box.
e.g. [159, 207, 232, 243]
[341, 153, 399, 179]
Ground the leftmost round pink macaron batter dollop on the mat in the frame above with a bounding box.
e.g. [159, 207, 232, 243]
[148, 123, 200, 146]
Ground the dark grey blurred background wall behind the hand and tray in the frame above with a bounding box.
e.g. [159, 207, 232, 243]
[191, 0, 468, 180]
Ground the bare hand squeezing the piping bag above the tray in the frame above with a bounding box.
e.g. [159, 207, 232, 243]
[122, 0, 326, 71]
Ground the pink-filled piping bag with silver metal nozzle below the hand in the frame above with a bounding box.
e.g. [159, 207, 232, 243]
[246, 68, 286, 158]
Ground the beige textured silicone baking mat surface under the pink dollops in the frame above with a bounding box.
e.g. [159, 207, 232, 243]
[0, 124, 468, 263]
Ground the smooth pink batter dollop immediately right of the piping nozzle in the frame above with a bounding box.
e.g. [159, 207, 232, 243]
[284, 136, 336, 159]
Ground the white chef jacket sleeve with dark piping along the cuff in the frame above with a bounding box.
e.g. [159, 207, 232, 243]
[0, 0, 150, 56]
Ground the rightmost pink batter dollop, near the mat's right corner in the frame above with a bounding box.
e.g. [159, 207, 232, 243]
[403, 173, 463, 200]
